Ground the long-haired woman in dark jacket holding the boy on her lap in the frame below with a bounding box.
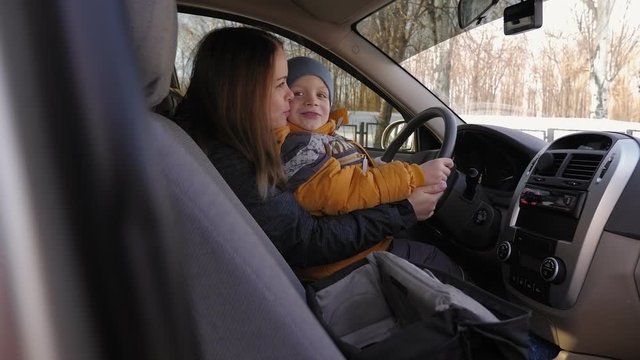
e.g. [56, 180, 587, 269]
[172, 28, 461, 278]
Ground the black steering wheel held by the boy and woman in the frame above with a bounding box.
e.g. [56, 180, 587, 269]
[381, 107, 501, 251]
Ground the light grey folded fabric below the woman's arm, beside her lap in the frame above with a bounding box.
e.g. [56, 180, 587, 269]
[316, 251, 499, 348]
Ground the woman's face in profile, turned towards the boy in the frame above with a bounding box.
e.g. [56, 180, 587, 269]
[269, 48, 293, 129]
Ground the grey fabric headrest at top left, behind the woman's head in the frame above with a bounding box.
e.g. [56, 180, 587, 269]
[124, 0, 178, 108]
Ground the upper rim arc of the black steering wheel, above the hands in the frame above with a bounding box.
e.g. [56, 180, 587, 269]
[381, 106, 458, 162]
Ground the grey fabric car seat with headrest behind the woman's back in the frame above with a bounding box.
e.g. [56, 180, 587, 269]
[125, 0, 342, 359]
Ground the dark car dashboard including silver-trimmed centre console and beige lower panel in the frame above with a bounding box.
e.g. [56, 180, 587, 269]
[448, 124, 640, 359]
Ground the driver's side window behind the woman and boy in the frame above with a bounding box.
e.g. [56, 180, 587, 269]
[175, 13, 415, 152]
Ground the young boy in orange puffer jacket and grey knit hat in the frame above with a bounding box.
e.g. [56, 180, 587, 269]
[276, 57, 453, 215]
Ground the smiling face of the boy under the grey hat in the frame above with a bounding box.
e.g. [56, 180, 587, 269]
[288, 75, 331, 131]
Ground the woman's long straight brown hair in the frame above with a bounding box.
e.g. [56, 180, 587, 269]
[176, 27, 285, 198]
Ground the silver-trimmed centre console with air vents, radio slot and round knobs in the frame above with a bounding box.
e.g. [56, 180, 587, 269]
[496, 132, 640, 358]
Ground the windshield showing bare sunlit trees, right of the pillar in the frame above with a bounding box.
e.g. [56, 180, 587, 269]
[358, 0, 640, 141]
